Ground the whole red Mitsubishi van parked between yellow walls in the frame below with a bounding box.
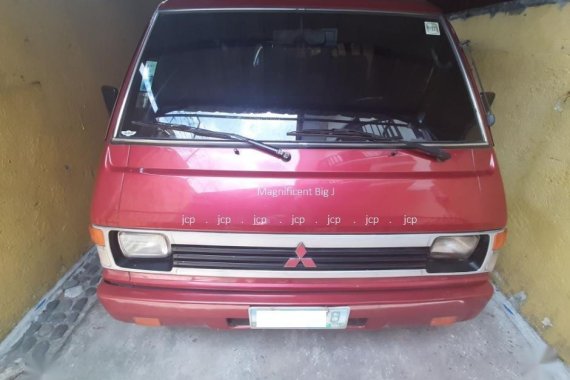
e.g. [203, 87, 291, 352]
[90, 0, 506, 329]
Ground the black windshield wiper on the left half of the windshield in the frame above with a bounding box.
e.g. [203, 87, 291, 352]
[131, 121, 291, 162]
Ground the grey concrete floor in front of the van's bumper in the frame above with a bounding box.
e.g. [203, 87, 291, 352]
[34, 294, 544, 380]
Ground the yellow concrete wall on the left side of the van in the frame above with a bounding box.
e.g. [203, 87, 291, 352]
[0, 0, 156, 339]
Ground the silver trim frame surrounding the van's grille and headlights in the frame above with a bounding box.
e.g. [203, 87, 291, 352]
[94, 226, 502, 278]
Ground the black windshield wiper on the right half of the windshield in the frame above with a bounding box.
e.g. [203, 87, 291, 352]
[287, 128, 451, 161]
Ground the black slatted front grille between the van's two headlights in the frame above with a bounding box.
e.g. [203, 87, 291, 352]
[172, 245, 429, 271]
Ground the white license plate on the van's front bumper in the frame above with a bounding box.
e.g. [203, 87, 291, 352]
[249, 307, 350, 329]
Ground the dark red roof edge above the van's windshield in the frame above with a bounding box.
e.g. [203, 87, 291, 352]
[159, 0, 441, 14]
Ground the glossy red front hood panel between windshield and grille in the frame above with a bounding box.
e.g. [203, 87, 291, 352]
[91, 144, 506, 233]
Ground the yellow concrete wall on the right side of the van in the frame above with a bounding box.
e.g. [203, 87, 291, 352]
[454, 5, 570, 361]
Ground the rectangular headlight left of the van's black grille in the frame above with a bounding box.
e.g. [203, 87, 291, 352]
[118, 232, 170, 258]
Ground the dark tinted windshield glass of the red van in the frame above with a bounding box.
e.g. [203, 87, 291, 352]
[117, 11, 483, 144]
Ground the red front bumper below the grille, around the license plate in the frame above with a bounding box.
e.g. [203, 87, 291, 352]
[97, 270, 493, 329]
